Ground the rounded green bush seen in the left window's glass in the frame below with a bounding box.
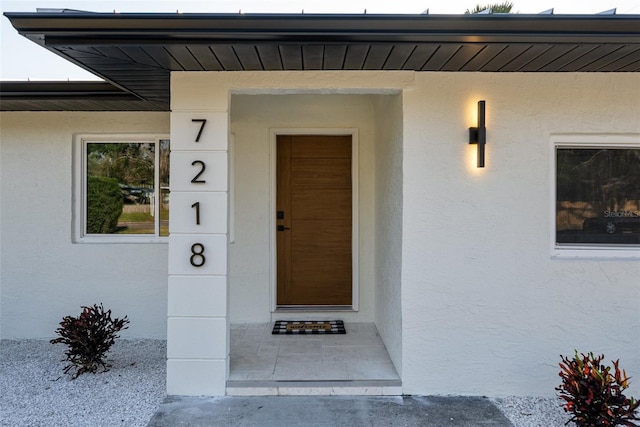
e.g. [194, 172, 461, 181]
[87, 175, 124, 234]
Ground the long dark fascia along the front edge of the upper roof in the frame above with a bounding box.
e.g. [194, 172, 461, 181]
[5, 12, 640, 46]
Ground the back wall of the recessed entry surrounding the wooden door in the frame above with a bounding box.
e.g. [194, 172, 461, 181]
[229, 94, 375, 322]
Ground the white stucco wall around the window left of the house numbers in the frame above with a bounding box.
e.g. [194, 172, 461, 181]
[0, 112, 169, 339]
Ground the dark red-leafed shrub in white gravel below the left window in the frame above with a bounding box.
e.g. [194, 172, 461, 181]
[50, 304, 129, 379]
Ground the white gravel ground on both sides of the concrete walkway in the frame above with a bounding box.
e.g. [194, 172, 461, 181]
[0, 339, 569, 427]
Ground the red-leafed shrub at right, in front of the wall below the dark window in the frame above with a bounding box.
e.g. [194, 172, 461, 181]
[556, 351, 640, 427]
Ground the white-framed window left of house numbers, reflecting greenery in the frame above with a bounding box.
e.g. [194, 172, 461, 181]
[75, 135, 169, 242]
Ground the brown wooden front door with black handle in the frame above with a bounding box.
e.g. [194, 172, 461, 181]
[276, 135, 352, 305]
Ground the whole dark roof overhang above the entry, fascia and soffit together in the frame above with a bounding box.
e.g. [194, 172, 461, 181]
[5, 11, 640, 109]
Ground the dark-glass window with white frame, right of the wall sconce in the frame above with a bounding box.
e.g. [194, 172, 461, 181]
[554, 137, 640, 253]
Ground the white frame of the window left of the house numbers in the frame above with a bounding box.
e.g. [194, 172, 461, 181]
[72, 133, 170, 243]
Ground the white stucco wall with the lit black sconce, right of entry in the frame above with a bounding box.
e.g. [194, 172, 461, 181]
[402, 73, 640, 396]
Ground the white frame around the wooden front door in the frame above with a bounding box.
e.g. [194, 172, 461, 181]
[269, 128, 360, 312]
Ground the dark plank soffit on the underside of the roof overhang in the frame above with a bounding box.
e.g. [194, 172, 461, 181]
[48, 43, 640, 108]
